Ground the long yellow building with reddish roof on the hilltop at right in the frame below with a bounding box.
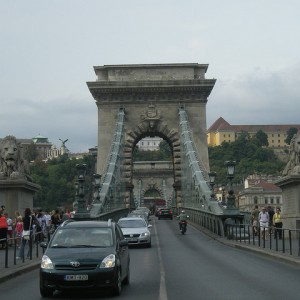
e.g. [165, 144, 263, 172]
[207, 117, 300, 148]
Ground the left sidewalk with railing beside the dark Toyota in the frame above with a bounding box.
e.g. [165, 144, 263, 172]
[0, 243, 43, 283]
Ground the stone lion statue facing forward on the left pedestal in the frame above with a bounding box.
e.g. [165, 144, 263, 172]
[0, 135, 32, 181]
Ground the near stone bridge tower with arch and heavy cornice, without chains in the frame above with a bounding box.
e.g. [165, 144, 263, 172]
[87, 63, 216, 207]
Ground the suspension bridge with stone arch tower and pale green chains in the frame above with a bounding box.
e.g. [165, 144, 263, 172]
[82, 63, 243, 235]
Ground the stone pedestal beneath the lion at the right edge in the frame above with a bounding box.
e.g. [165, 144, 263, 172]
[275, 175, 300, 234]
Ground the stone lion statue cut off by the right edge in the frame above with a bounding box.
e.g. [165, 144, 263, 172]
[282, 132, 300, 176]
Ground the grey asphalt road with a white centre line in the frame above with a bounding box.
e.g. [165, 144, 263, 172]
[0, 217, 300, 300]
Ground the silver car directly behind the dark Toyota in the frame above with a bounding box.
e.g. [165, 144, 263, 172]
[118, 217, 152, 248]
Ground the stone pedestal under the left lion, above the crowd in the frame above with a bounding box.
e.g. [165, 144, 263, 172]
[0, 179, 40, 217]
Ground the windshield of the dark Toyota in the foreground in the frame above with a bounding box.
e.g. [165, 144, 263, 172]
[50, 227, 113, 248]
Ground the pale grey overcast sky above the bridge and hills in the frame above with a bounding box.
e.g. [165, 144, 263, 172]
[0, 0, 300, 152]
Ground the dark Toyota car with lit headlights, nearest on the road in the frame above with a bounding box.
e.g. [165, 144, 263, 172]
[40, 219, 130, 297]
